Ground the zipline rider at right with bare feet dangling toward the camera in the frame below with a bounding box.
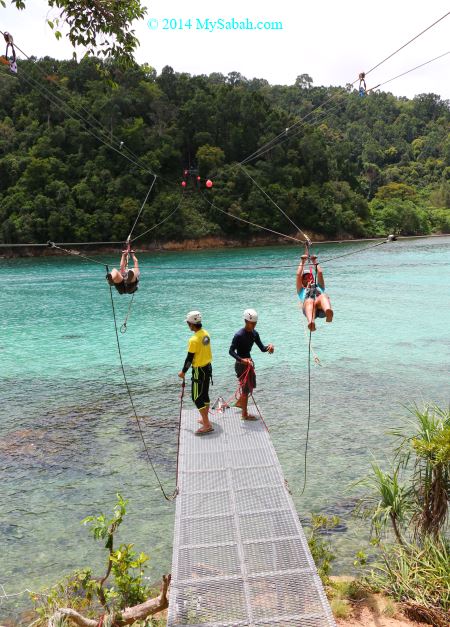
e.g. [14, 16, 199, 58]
[296, 255, 333, 331]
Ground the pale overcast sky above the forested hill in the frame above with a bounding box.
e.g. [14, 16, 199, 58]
[0, 0, 450, 99]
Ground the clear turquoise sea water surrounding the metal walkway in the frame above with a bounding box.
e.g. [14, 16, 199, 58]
[0, 237, 450, 619]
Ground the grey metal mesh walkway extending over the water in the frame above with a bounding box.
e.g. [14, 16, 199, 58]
[167, 408, 335, 627]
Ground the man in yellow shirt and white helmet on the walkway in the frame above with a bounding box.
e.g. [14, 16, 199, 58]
[178, 311, 214, 435]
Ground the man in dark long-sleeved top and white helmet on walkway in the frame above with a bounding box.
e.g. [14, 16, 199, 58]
[229, 309, 275, 420]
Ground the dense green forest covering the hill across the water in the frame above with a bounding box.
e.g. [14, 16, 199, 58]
[0, 58, 450, 243]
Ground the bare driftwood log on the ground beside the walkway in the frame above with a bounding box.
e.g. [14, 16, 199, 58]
[48, 575, 170, 627]
